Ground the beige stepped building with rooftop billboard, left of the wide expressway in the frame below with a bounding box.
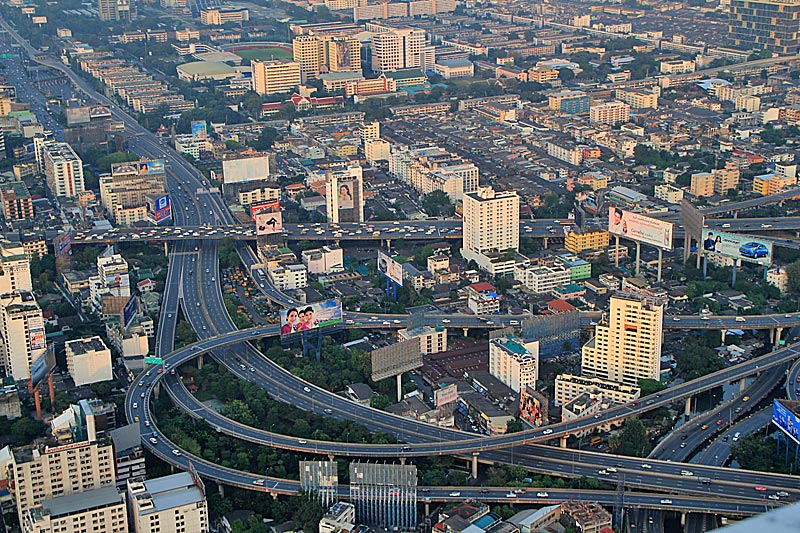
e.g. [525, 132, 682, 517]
[99, 160, 167, 226]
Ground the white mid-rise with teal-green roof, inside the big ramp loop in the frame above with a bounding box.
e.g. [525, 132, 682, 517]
[489, 335, 539, 392]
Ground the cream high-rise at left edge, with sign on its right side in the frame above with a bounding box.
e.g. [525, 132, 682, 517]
[0, 291, 47, 381]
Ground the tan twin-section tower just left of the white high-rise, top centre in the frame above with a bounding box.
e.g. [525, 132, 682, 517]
[292, 35, 361, 82]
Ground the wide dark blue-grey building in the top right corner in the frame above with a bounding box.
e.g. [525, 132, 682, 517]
[728, 0, 800, 55]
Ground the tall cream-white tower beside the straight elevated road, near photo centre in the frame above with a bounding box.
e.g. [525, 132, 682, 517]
[461, 187, 519, 274]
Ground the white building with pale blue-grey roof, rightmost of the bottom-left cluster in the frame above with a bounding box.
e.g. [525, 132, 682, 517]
[128, 472, 209, 533]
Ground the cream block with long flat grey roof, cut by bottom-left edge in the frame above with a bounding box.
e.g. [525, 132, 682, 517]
[22, 487, 128, 533]
